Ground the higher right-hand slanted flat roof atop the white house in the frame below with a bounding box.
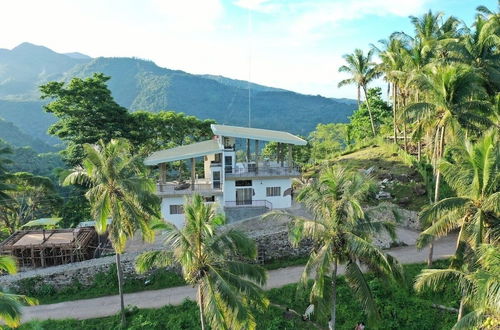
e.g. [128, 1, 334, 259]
[210, 124, 307, 146]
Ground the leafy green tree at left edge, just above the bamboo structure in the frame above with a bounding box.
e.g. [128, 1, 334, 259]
[0, 172, 61, 234]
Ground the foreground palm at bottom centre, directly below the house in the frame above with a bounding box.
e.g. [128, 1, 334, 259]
[136, 195, 268, 329]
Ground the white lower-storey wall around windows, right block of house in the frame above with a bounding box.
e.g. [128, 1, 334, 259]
[224, 178, 292, 209]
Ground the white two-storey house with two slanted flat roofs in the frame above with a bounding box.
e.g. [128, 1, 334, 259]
[144, 125, 306, 227]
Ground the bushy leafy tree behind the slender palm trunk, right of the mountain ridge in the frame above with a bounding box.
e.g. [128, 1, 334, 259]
[349, 87, 392, 141]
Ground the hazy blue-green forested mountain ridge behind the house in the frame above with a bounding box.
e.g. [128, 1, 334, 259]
[0, 43, 355, 148]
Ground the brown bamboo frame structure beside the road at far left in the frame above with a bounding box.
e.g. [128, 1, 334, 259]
[0, 227, 99, 268]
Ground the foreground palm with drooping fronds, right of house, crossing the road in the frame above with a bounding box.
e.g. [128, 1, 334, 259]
[266, 167, 402, 329]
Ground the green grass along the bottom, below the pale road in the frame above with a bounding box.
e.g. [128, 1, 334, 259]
[17, 261, 459, 330]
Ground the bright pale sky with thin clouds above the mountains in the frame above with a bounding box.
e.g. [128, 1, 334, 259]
[0, 0, 497, 98]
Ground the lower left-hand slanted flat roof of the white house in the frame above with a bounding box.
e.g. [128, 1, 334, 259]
[144, 140, 222, 165]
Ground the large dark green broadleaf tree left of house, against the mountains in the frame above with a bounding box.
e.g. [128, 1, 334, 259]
[40, 73, 129, 166]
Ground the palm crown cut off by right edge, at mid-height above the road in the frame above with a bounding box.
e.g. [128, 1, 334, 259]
[418, 131, 500, 249]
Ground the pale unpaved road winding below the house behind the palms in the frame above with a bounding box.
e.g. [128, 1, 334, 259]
[22, 236, 456, 322]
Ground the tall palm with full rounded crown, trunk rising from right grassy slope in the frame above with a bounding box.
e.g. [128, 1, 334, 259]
[405, 65, 491, 265]
